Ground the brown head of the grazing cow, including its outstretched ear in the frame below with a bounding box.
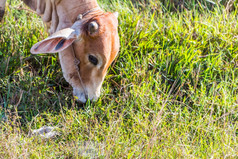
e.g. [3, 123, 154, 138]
[31, 13, 119, 103]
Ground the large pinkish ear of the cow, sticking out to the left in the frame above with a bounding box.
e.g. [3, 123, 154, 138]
[31, 28, 78, 54]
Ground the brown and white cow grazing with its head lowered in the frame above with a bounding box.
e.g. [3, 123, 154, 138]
[0, 0, 120, 103]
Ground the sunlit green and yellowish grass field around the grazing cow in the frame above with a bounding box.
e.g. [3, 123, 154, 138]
[0, 0, 238, 158]
